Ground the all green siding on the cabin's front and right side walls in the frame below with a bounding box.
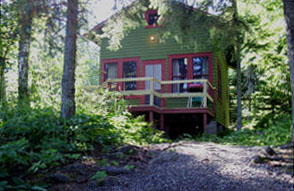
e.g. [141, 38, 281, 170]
[101, 25, 229, 127]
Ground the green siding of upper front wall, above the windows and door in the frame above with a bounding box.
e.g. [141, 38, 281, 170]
[101, 28, 212, 60]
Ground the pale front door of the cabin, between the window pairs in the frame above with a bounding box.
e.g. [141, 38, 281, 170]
[143, 60, 165, 107]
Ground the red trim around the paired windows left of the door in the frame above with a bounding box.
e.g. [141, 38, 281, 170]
[101, 57, 141, 99]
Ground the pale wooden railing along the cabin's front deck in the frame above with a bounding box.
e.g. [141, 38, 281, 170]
[103, 77, 215, 108]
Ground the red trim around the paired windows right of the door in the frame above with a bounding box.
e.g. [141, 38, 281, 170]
[168, 52, 213, 92]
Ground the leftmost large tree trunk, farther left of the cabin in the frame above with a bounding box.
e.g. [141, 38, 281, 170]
[18, 0, 33, 103]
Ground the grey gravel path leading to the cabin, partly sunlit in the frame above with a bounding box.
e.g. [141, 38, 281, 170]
[100, 142, 294, 191]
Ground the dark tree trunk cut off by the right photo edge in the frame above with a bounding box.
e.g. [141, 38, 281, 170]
[284, 0, 294, 144]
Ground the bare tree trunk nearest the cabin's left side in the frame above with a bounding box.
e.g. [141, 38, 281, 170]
[61, 0, 78, 119]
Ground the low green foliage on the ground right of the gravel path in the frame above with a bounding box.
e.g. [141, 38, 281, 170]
[196, 115, 291, 146]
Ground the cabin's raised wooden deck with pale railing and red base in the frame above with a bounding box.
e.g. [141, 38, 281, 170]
[87, 77, 215, 130]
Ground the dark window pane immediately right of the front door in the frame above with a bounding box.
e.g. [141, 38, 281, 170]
[172, 58, 188, 92]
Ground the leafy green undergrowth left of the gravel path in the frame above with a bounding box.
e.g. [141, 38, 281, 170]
[0, 91, 166, 191]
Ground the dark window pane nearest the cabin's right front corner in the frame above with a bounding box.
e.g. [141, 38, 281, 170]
[193, 57, 209, 79]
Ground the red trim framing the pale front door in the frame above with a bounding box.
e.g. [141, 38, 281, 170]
[141, 59, 166, 107]
